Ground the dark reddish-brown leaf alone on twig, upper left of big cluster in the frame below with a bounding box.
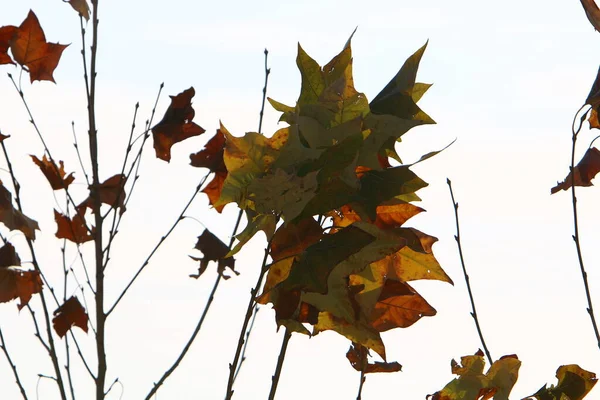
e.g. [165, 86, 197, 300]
[152, 87, 205, 162]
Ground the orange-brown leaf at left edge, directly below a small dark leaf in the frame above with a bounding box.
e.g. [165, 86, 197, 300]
[0, 266, 43, 310]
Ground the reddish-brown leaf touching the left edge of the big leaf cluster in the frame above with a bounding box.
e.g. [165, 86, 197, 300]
[190, 129, 227, 213]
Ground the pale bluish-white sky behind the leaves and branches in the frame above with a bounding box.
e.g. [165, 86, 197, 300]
[0, 0, 600, 400]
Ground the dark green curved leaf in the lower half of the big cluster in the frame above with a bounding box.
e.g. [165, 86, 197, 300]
[280, 226, 375, 294]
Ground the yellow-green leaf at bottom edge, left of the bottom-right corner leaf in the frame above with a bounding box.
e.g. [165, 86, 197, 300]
[427, 350, 521, 400]
